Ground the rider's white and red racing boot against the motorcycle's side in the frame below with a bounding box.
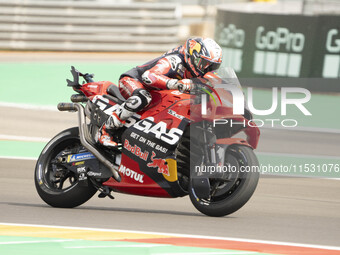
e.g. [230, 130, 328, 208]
[97, 103, 134, 147]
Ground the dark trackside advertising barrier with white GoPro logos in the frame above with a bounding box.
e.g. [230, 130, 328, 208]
[215, 4, 340, 92]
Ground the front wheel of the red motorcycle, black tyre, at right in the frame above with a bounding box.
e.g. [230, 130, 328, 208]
[189, 145, 259, 217]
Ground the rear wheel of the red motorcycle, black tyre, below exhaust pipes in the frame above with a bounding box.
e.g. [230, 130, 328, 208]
[34, 127, 97, 208]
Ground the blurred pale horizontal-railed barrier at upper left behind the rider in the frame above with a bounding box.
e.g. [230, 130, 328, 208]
[0, 0, 181, 52]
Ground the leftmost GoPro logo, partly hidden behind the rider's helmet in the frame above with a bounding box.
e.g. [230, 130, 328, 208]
[217, 23, 245, 72]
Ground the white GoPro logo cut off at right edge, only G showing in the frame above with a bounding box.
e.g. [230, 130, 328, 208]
[322, 28, 340, 78]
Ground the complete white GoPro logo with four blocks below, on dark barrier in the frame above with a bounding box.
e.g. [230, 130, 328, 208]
[253, 26, 305, 77]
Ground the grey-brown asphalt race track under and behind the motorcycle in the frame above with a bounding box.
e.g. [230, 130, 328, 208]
[0, 107, 340, 246]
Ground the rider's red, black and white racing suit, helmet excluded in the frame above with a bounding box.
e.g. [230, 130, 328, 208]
[98, 46, 220, 146]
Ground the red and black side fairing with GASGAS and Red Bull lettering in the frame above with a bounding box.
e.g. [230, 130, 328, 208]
[105, 91, 190, 197]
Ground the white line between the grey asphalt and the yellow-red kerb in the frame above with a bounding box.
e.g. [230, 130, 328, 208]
[0, 222, 340, 251]
